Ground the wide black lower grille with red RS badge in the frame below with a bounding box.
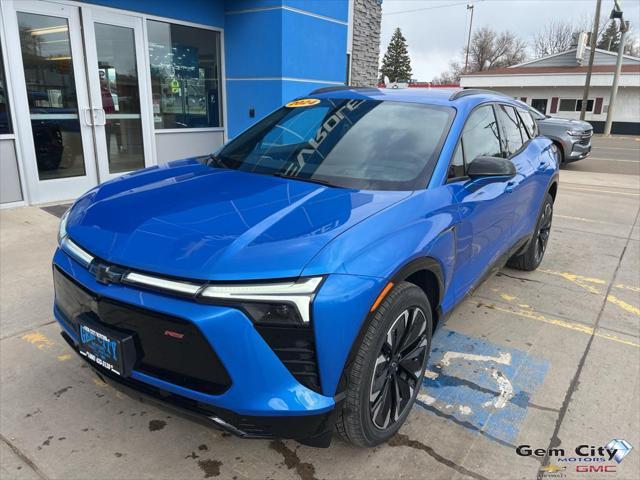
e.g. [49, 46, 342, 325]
[53, 267, 231, 395]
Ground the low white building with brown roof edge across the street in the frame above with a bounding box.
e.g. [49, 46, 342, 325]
[460, 47, 640, 135]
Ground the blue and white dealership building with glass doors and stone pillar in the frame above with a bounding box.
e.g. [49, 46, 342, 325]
[0, 0, 381, 207]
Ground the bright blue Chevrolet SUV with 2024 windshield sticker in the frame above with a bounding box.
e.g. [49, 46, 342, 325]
[53, 87, 558, 446]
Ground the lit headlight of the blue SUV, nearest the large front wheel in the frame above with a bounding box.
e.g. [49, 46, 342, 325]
[199, 277, 322, 325]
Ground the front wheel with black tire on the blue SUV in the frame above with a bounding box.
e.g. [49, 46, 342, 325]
[336, 282, 433, 447]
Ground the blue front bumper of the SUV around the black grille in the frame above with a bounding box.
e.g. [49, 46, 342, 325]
[53, 250, 379, 446]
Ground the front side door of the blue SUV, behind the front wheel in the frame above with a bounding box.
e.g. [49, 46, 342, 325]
[447, 104, 513, 300]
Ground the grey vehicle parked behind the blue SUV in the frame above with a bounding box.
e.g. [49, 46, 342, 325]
[528, 107, 593, 167]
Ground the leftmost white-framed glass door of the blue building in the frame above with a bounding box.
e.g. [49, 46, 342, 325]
[2, 0, 97, 203]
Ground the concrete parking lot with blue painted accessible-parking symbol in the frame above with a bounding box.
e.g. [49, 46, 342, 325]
[0, 137, 640, 480]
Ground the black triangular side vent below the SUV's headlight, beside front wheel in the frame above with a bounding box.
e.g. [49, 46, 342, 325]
[256, 324, 321, 393]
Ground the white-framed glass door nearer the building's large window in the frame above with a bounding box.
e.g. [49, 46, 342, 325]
[81, 7, 151, 182]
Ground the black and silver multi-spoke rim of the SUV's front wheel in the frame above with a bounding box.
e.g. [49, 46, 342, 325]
[369, 307, 428, 430]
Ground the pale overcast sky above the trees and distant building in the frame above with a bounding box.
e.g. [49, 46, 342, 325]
[380, 0, 640, 81]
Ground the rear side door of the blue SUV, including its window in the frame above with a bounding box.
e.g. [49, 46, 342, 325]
[496, 104, 540, 245]
